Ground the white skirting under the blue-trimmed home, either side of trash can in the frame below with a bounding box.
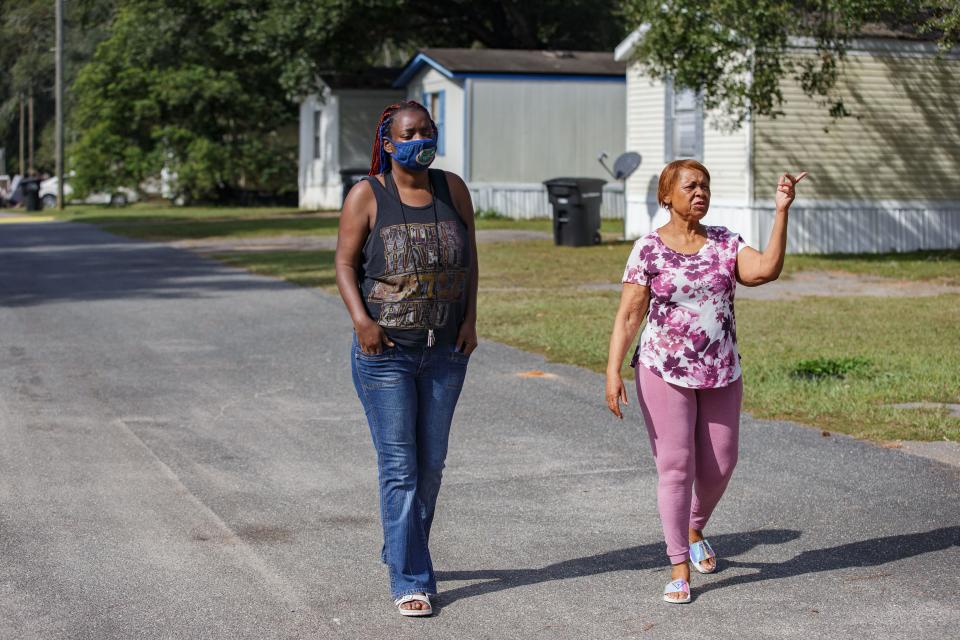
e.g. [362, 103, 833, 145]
[469, 183, 627, 220]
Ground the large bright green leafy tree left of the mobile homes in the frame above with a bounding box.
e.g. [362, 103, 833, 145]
[70, 0, 296, 199]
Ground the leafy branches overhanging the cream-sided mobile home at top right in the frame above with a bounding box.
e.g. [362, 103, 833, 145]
[623, 0, 960, 126]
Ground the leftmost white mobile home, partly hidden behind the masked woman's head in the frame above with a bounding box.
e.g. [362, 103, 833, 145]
[298, 69, 404, 209]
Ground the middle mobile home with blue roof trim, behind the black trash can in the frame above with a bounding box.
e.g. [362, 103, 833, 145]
[395, 49, 626, 218]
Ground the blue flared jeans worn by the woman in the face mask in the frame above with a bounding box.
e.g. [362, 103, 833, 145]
[350, 335, 469, 598]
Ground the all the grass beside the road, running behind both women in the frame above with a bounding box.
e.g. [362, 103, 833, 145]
[22, 207, 960, 441]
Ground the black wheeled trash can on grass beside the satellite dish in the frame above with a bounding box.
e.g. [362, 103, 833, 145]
[543, 178, 607, 247]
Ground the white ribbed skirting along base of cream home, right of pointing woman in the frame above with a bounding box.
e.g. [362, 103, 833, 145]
[756, 202, 960, 253]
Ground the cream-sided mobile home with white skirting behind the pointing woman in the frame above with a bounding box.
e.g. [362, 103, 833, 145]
[615, 30, 960, 253]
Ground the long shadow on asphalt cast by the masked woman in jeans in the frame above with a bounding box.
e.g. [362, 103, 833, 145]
[437, 529, 800, 606]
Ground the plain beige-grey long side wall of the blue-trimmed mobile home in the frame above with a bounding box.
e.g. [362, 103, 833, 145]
[470, 79, 626, 184]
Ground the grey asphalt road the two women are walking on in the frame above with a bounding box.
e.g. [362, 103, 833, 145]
[0, 223, 960, 640]
